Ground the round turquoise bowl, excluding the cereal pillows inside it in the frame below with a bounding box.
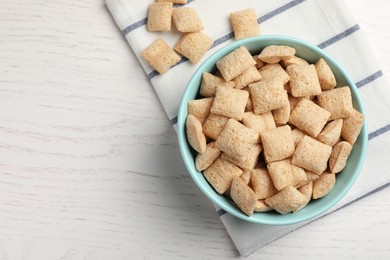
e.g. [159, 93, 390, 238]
[177, 35, 368, 225]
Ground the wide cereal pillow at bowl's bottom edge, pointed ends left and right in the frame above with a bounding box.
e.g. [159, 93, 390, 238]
[265, 186, 307, 214]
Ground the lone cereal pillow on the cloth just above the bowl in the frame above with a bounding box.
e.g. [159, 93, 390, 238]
[230, 8, 260, 40]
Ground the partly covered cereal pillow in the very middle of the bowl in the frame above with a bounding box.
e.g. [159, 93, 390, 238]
[242, 112, 276, 136]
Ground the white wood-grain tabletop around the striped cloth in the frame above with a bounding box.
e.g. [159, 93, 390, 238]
[0, 0, 390, 259]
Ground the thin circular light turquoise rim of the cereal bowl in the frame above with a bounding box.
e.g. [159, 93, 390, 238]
[177, 35, 368, 226]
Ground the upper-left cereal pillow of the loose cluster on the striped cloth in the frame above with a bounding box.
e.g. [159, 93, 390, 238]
[146, 3, 173, 32]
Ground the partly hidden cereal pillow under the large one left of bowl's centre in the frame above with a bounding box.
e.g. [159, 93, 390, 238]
[221, 144, 262, 170]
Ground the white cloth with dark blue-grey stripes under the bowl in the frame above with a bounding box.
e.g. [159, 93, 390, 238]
[106, 0, 390, 255]
